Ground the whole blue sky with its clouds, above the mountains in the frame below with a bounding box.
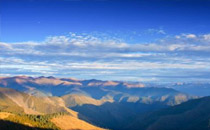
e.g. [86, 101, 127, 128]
[0, 0, 210, 82]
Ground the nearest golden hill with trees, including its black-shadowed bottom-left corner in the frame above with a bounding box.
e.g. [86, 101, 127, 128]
[0, 112, 105, 130]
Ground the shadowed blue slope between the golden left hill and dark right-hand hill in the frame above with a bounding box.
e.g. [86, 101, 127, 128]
[71, 102, 167, 130]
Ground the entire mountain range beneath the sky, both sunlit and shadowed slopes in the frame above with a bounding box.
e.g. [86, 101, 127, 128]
[0, 76, 210, 130]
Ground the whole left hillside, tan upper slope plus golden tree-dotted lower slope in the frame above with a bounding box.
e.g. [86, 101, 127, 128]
[0, 87, 106, 130]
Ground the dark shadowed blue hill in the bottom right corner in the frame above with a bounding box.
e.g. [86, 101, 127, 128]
[125, 97, 210, 130]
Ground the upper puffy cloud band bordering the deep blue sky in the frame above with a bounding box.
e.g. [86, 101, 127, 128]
[0, 34, 210, 58]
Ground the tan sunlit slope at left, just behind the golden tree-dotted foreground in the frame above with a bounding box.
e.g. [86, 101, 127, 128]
[0, 87, 67, 114]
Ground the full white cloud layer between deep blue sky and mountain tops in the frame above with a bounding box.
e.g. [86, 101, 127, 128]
[0, 30, 210, 81]
